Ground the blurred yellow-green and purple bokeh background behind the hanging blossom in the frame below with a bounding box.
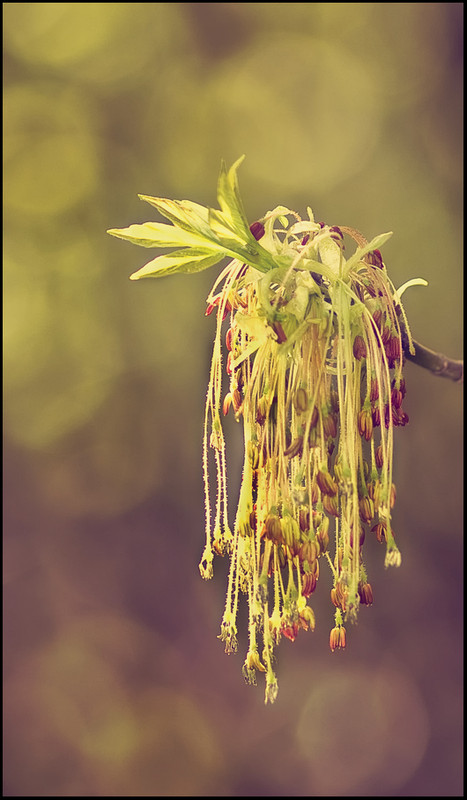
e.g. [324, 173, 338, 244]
[3, 3, 463, 797]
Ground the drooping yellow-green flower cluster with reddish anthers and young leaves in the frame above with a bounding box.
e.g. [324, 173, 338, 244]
[109, 159, 425, 702]
